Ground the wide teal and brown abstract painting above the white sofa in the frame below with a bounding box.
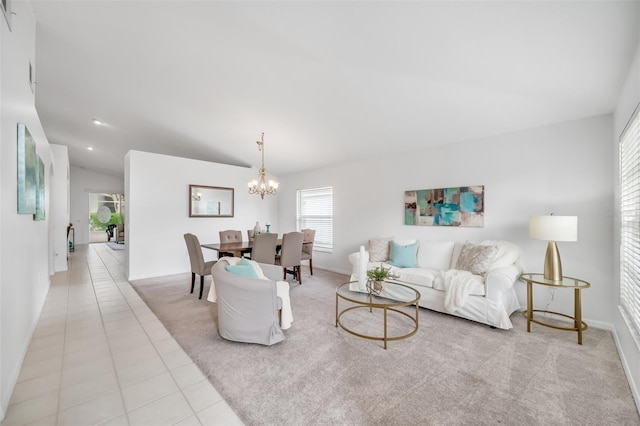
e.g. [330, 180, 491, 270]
[404, 185, 484, 227]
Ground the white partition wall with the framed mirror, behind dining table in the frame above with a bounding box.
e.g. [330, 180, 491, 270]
[125, 151, 278, 285]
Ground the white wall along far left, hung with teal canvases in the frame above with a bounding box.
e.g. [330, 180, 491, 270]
[0, 1, 60, 418]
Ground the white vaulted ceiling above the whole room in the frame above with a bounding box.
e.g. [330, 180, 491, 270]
[31, 0, 640, 176]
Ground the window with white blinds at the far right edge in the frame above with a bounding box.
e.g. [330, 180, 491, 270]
[620, 106, 640, 334]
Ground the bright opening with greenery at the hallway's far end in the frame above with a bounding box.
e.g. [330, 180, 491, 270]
[89, 192, 124, 243]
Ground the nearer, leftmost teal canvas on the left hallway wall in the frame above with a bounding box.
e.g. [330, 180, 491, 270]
[18, 123, 38, 214]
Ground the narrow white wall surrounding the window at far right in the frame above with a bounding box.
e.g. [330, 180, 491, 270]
[611, 43, 640, 407]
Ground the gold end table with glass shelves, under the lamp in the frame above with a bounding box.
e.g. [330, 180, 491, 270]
[521, 274, 591, 345]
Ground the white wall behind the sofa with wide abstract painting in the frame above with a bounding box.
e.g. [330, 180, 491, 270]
[279, 115, 614, 325]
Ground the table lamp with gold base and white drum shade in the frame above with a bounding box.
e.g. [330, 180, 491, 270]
[529, 213, 578, 281]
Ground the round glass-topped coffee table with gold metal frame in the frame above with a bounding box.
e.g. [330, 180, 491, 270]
[336, 282, 420, 349]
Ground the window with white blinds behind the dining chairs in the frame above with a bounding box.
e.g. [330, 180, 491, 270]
[297, 186, 333, 251]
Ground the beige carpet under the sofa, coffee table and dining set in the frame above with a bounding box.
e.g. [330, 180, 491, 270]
[132, 269, 640, 425]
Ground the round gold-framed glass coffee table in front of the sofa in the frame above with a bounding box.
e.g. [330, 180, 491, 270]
[336, 281, 420, 349]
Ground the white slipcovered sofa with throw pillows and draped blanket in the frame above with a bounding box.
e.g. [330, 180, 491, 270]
[349, 238, 525, 329]
